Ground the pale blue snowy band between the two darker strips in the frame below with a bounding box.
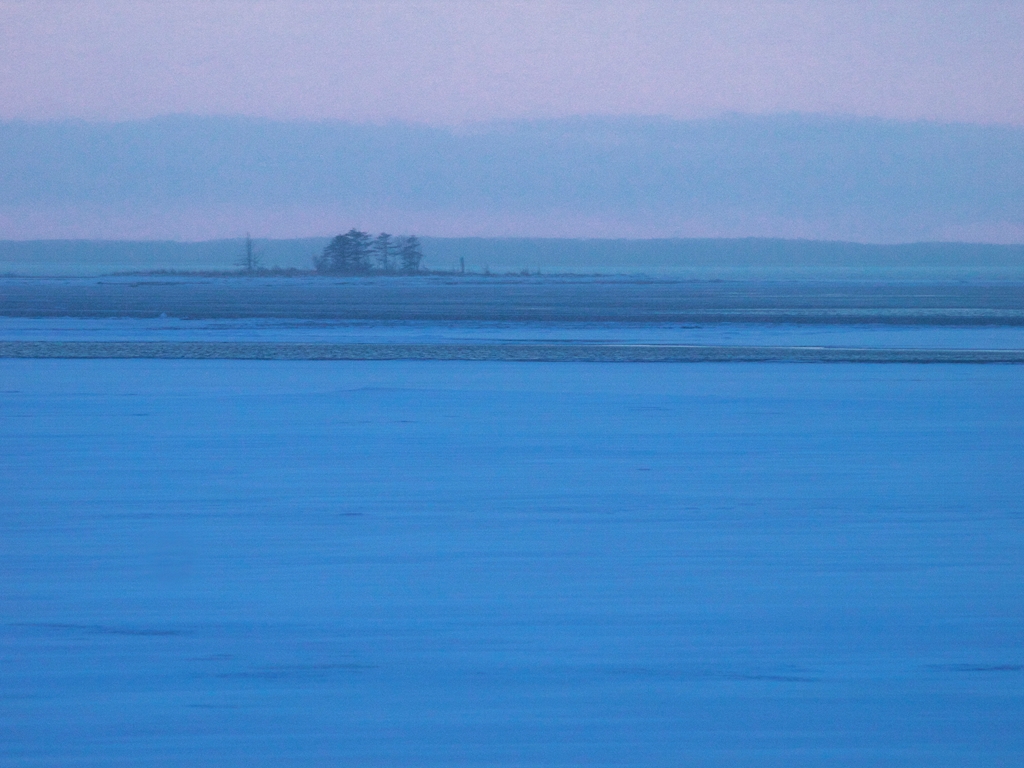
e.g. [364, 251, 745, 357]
[0, 316, 1024, 349]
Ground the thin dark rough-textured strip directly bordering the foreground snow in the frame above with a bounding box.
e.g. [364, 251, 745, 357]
[0, 341, 1024, 364]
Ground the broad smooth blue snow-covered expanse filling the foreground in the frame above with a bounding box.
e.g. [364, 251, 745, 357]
[0, 362, 1024, 768]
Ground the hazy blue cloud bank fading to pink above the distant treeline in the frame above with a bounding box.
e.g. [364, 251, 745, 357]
[0, 115, 1024, 244]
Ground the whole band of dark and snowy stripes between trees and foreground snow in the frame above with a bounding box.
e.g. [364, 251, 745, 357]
[0, 275, 1024, 364]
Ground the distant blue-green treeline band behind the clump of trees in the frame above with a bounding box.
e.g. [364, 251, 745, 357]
[0, 237, 1024, 280]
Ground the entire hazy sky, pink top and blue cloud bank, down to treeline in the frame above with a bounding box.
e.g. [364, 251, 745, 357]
[0, 0, 1024, 243]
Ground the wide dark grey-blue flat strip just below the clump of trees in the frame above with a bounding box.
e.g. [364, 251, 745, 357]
[0, 276, 1024, 326]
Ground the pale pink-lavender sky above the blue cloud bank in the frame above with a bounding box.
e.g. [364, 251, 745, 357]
[6, 0, 1024, 125]
